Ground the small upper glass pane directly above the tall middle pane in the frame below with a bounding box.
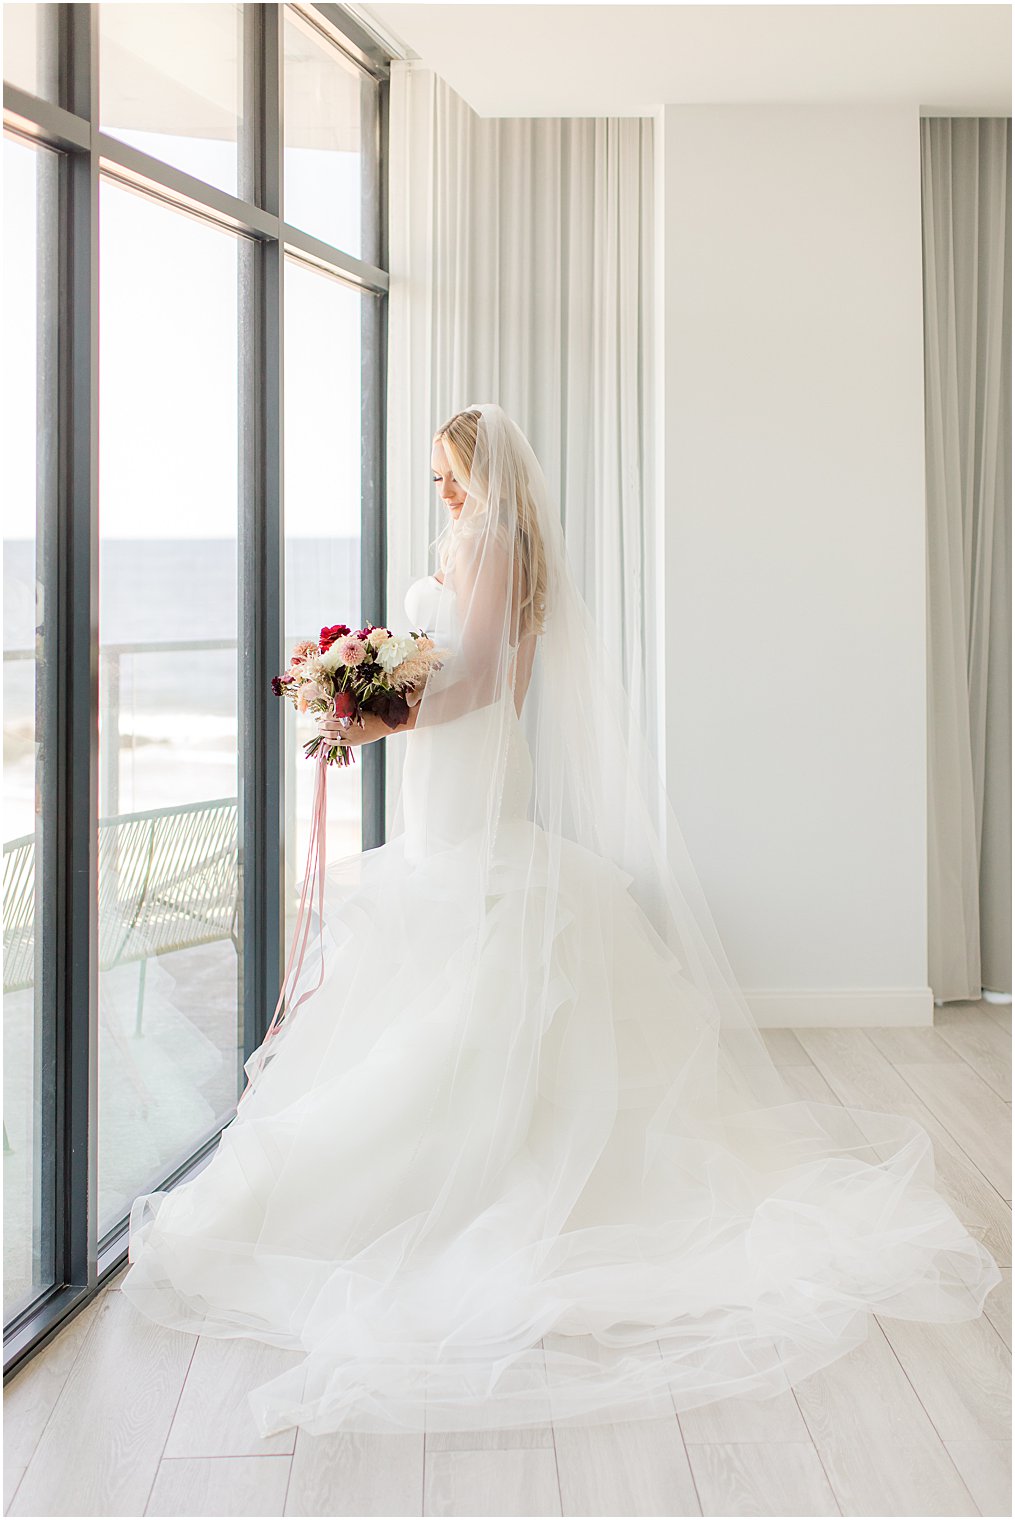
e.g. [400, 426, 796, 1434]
[97, 5, 243, 195]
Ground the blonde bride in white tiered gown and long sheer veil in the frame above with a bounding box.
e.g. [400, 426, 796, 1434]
[123, 403, 1000, 1436]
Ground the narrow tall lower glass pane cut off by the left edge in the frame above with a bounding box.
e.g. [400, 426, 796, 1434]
[3, 137, 59, 1321]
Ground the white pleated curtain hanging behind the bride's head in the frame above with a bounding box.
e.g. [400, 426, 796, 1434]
[387, 61, 661, 778]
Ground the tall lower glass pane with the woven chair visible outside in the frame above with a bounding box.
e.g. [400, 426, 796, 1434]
[99, 179, 242, 1234]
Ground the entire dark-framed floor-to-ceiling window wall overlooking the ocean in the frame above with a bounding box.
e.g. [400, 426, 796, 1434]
[3, 3, 387, 1368]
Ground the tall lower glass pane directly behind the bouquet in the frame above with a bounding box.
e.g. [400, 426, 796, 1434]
[283, 258, 366, 924]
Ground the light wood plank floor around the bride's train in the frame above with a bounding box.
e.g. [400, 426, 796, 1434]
[5, 1003, 1012, 1515]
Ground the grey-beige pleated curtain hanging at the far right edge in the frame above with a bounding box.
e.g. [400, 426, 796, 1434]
[921, 117, 1012, 1002]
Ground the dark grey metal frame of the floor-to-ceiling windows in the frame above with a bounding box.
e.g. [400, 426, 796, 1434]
[3, 3, 391, 1382]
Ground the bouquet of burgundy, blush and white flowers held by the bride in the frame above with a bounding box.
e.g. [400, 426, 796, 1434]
[272, 623, 447, 765]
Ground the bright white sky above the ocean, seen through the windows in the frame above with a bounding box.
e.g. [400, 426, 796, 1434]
[3, 132, 366, 538]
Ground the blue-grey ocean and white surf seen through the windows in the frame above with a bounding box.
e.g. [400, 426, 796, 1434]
[3, 538, 369, 848]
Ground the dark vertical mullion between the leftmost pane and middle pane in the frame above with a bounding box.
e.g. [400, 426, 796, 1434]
[56, 5, 99, 1319]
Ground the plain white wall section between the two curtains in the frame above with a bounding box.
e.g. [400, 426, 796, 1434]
[656, 105, 933, 1026]
